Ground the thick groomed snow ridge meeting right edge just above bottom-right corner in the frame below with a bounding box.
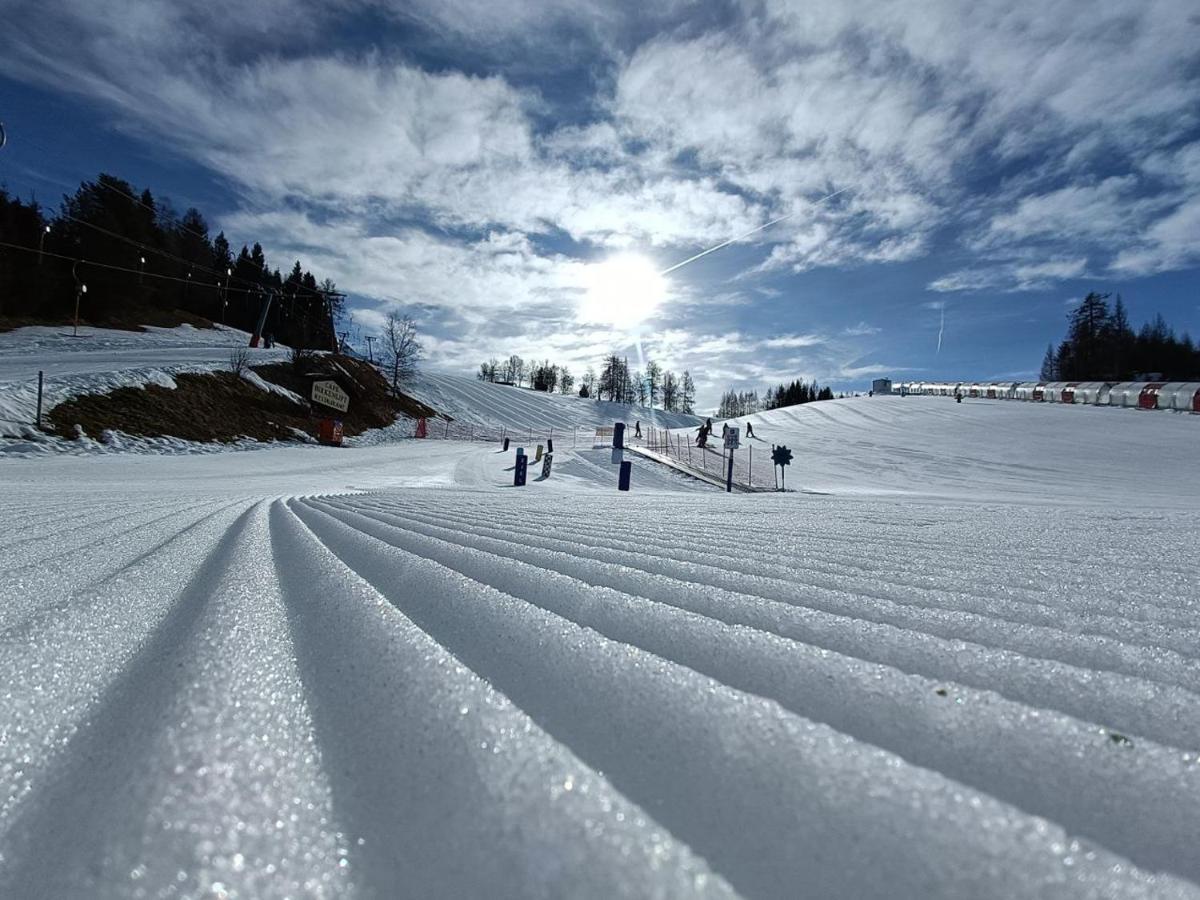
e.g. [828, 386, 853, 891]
[310, 503, 1200, 878]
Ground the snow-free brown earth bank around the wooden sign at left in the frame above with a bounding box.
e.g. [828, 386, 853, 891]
[47, 356, 437, 442]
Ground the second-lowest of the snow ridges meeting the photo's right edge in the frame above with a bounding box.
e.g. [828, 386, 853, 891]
[324, 509, 1200, 750]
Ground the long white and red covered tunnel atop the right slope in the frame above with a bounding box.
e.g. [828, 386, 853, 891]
[892, 382, 1200, 413]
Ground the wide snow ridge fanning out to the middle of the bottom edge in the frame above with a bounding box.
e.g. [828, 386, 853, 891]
[271, 502, 733, 899]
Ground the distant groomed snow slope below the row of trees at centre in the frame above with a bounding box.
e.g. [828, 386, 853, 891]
[404, 372, 701, 431]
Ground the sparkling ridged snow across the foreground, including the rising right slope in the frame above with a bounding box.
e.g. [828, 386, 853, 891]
[0, 398, 1200, 898]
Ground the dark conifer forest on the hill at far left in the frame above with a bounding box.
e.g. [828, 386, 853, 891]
[0, 174, 344, 349]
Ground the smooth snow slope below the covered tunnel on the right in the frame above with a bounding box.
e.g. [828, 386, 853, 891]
[691, 396, 1200, 509]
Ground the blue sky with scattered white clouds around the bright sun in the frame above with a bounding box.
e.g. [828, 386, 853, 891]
[0, 0, 1200, 403]
